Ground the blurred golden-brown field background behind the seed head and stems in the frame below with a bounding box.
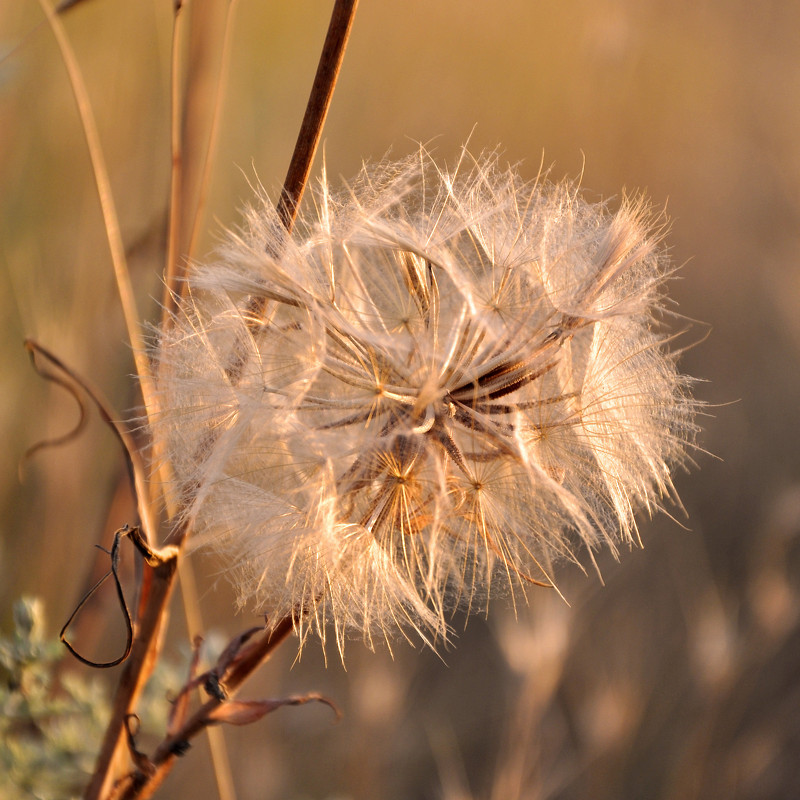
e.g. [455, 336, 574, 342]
[0, 0, 800, 800]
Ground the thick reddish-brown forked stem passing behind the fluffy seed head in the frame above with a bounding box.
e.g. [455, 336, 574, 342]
[83, 0, 357, 800]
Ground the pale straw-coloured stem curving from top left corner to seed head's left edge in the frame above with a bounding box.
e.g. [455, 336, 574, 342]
[39, 0, 154, 424]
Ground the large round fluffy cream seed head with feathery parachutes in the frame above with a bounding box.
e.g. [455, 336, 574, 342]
[153, 151, 695, 646]
